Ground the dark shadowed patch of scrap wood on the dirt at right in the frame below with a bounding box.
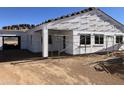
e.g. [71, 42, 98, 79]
[94, 57, 124, 79]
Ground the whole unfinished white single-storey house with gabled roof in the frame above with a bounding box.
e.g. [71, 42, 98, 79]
[0, 8, 124, 57]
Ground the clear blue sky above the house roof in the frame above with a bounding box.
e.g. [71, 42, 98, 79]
[0, 7, 124, 28]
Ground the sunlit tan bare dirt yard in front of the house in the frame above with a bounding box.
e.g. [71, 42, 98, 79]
[0, 51, 124, 85]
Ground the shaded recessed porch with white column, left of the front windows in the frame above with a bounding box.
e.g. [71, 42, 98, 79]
[28, 28, 73, 58]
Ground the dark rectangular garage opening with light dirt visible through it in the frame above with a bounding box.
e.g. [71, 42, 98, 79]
[3, 36, 21, 50]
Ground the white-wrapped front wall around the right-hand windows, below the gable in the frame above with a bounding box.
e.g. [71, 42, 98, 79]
[73, 31, 124, 55]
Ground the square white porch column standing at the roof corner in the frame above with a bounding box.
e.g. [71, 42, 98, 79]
[42, 28, 48, 57]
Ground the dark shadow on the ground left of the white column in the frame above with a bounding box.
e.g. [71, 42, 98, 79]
[0, 49, 42, 62]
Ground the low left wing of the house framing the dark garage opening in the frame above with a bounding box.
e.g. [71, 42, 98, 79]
[0, 30, 27, 50]
